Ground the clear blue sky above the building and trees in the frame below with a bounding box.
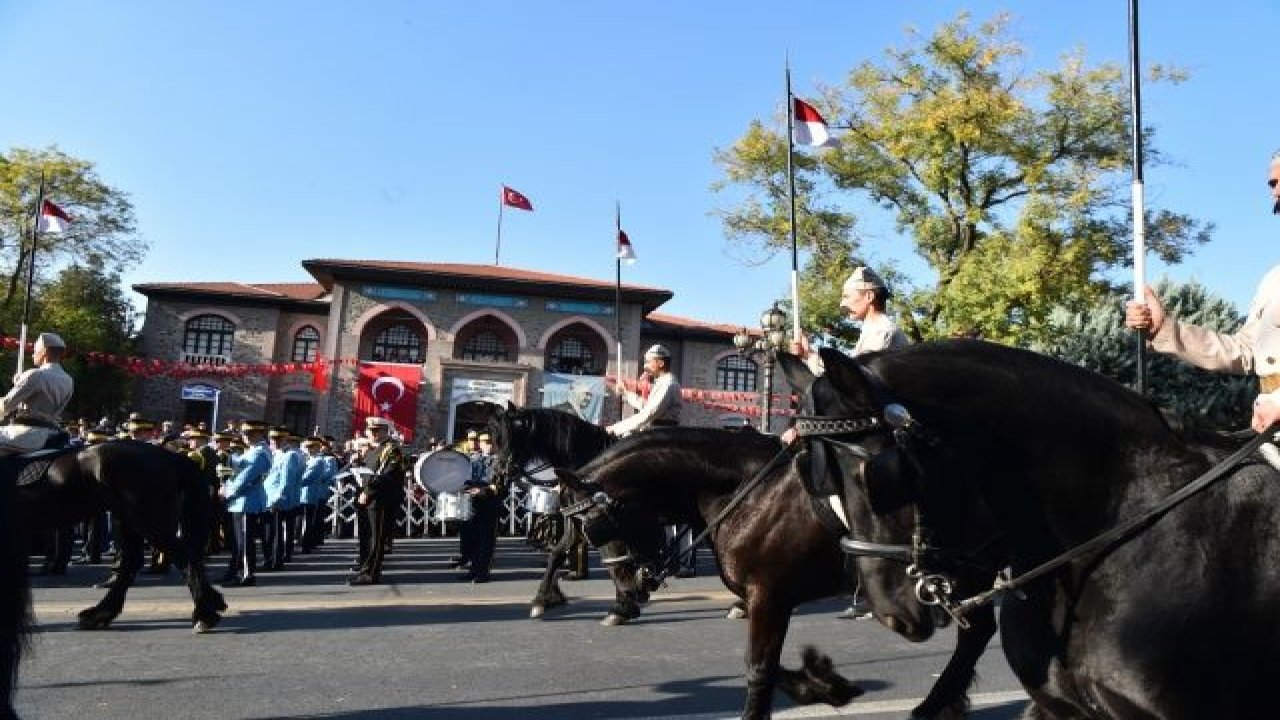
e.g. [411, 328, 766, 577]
[0, 0, 1280, 324]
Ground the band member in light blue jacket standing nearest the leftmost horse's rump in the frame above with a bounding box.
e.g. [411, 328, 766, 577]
[219, 420, 271, 587]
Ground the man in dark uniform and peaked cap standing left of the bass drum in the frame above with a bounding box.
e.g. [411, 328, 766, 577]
[348, 416, 407, 585]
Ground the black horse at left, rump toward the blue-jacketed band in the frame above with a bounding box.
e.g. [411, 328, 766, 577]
[8, 441, 227, 633]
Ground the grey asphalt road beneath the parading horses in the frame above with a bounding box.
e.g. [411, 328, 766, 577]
[18, 539, 1025, 720]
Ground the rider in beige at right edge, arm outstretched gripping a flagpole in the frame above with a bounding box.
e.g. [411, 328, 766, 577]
[1125, 154, 1280, 433]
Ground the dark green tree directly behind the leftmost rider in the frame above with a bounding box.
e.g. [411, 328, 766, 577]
[0, 265, 133, 420]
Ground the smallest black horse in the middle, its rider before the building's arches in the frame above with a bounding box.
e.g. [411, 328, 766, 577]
[489, 405, 648, 625]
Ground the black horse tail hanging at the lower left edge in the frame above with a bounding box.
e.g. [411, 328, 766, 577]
[0, 477, 33, 717]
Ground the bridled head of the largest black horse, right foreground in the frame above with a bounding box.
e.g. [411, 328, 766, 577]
[782, 348, 933, 641]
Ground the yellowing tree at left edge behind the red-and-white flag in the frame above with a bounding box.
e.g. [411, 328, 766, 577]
[0, 147, 146, 311]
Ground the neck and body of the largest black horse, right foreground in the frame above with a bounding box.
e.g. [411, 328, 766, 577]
[819, 341, 1280, 719]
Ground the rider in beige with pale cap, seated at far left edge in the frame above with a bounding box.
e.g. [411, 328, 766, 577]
[0, 333, 76, 455]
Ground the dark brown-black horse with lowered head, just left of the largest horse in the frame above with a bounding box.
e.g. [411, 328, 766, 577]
[557, 428, 947, 717]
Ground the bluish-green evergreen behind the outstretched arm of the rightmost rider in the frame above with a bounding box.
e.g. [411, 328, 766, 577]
[1034, 279, 1258, 429]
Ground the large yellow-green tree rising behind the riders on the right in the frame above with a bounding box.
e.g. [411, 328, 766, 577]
[716, 14, 1212, 345]
